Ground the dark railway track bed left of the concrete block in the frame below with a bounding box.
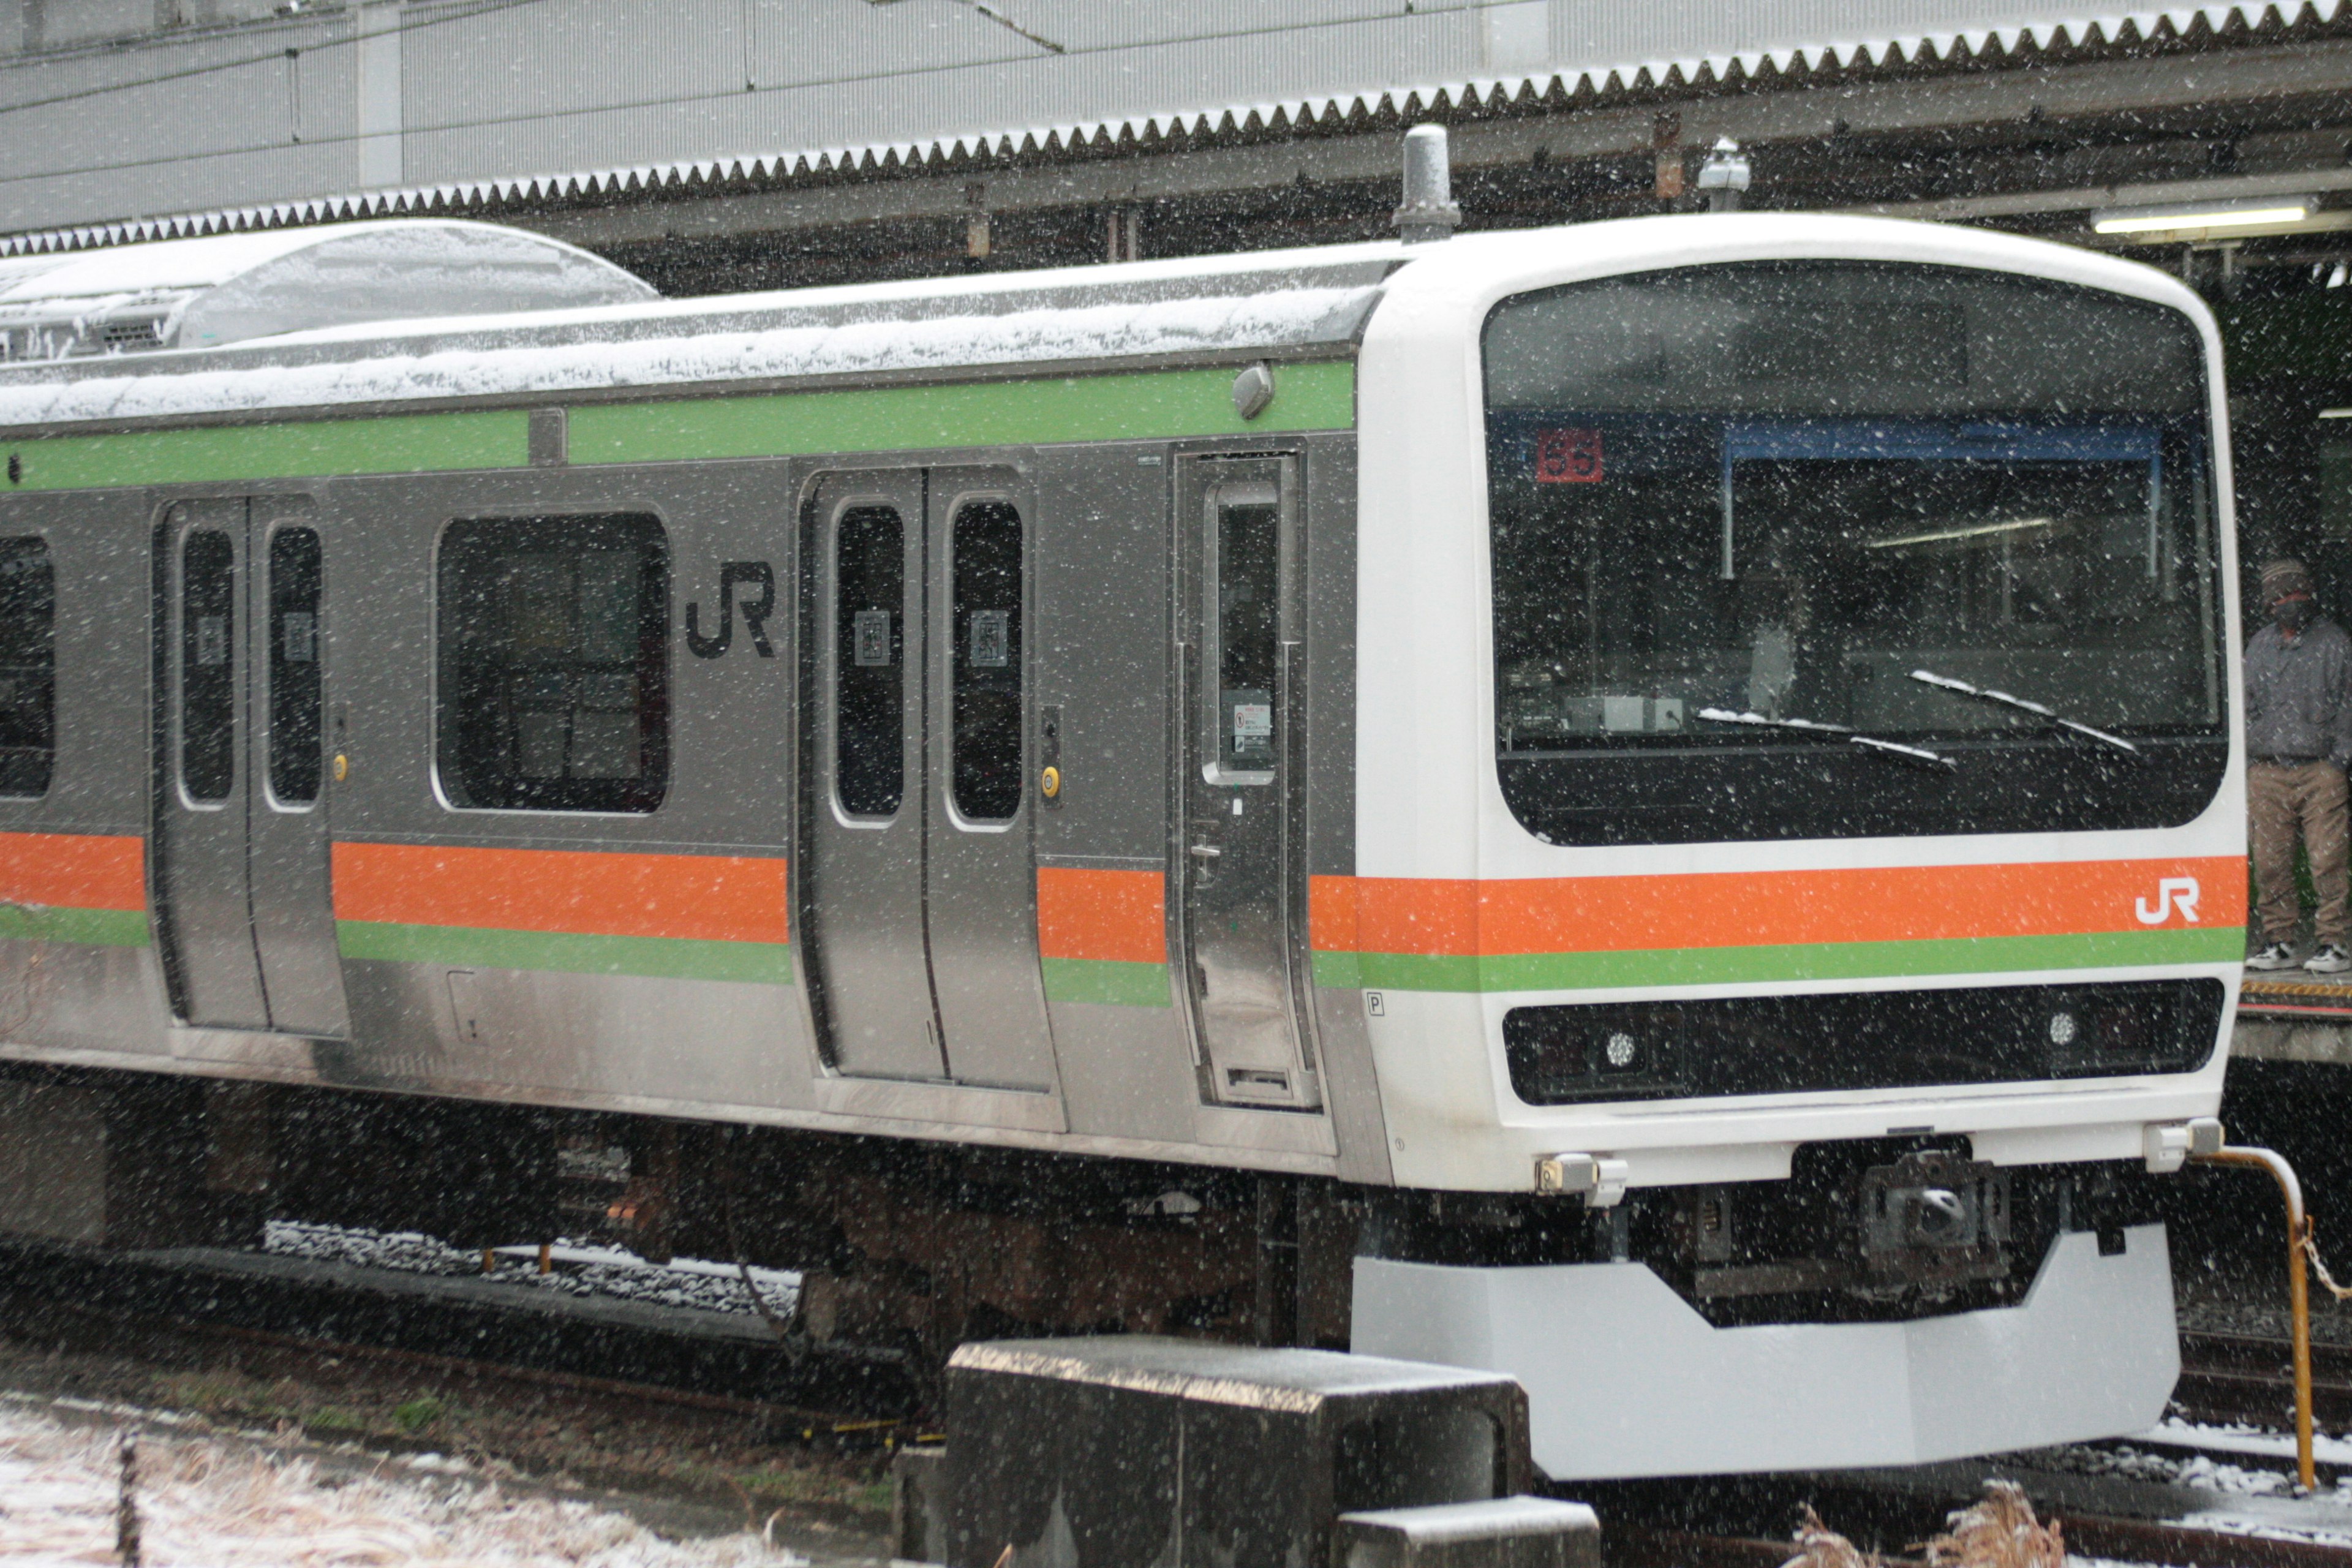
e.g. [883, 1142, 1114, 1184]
[0, 1242, 927, 1504]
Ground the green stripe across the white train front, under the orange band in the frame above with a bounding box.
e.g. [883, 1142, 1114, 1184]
[1315, 926, 2246, 992]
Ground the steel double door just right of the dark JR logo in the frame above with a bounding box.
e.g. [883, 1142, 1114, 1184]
[795, 470, 1054, 1091]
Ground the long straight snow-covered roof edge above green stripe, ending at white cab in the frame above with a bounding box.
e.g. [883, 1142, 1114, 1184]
[0, 225, 1406, 428]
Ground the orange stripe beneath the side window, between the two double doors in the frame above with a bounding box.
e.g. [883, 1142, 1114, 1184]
[334, 844, 788, 943]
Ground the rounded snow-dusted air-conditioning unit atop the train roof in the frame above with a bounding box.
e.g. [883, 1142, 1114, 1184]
[0, 219, 656, 360]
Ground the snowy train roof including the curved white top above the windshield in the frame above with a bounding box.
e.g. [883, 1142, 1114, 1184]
[0, 214, 2195, 430]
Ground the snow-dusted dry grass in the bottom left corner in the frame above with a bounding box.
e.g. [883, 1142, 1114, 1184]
[0, 1406, 804, 1568]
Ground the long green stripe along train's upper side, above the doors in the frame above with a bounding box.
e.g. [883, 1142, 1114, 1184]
[7, 362, 1355, 489]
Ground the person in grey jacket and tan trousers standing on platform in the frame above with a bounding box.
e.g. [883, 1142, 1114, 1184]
[2246, 559, 2352, 976]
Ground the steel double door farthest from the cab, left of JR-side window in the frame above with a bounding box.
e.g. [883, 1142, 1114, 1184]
[155, 496, 348, 1035]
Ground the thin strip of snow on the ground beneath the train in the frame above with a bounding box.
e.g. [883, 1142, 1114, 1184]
[261, 1220, 800, 1316]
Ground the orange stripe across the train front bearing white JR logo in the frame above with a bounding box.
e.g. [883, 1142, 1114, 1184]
[1310, 856, 2246, 957]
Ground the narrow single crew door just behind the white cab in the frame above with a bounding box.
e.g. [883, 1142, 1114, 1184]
[1169, 458, 1319, 1110]
